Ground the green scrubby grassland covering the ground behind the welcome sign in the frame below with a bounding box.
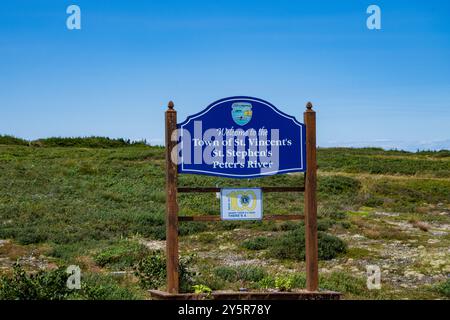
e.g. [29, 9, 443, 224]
[0, 136, 450, 299]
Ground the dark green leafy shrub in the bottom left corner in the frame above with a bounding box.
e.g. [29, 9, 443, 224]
[0, 263, 70, 300]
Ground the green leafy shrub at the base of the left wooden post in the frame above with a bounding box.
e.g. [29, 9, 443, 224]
[135, 251, 193, 292]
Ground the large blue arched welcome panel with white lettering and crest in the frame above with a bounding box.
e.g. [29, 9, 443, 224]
[175, 97, 306, 178]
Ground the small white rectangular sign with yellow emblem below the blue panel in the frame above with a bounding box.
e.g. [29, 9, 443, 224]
[220, 188, 263, 220]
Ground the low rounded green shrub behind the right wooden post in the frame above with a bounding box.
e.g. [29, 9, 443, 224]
[269, 228, 347, 260]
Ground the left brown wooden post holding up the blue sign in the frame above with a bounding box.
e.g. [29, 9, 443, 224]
[166, 101, 179, 293]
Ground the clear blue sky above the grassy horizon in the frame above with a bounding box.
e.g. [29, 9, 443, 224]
[0, 0, 450, 147]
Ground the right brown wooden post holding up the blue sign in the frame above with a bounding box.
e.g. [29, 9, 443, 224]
[303, 102, 319, 291]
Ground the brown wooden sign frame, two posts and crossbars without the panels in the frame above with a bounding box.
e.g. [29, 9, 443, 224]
[165, 97, 319, 297]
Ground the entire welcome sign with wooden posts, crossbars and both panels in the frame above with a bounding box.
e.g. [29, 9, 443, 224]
[162, 97, 320, 298]
